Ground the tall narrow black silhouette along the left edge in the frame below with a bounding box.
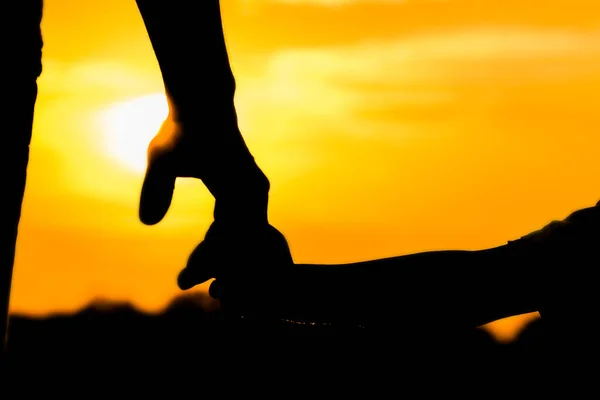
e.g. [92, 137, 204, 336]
[0, 0, 42, 374]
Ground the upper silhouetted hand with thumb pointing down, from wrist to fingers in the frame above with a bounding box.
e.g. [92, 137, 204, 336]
[139, 114, 270, 225]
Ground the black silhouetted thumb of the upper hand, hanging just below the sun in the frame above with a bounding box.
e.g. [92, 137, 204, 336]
[139, 151, 177, 225]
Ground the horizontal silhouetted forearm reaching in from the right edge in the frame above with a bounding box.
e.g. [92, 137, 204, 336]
[206, 201, 600, 338]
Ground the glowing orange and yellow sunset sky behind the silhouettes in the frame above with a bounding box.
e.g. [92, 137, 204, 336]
[11, 0, 600, 344]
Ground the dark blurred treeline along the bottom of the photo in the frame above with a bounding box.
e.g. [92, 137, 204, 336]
[1, 294, 572, 398]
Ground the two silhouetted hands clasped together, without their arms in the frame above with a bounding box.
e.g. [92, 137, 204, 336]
[139, 117, 293, 312]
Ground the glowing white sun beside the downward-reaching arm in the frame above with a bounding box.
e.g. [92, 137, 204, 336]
[101, 93, 169, 173]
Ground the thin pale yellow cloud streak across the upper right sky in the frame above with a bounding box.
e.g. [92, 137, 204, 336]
[270, 27, 600, 83]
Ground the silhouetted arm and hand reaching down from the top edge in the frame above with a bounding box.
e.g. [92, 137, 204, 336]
[137, 0, 269, 224]
